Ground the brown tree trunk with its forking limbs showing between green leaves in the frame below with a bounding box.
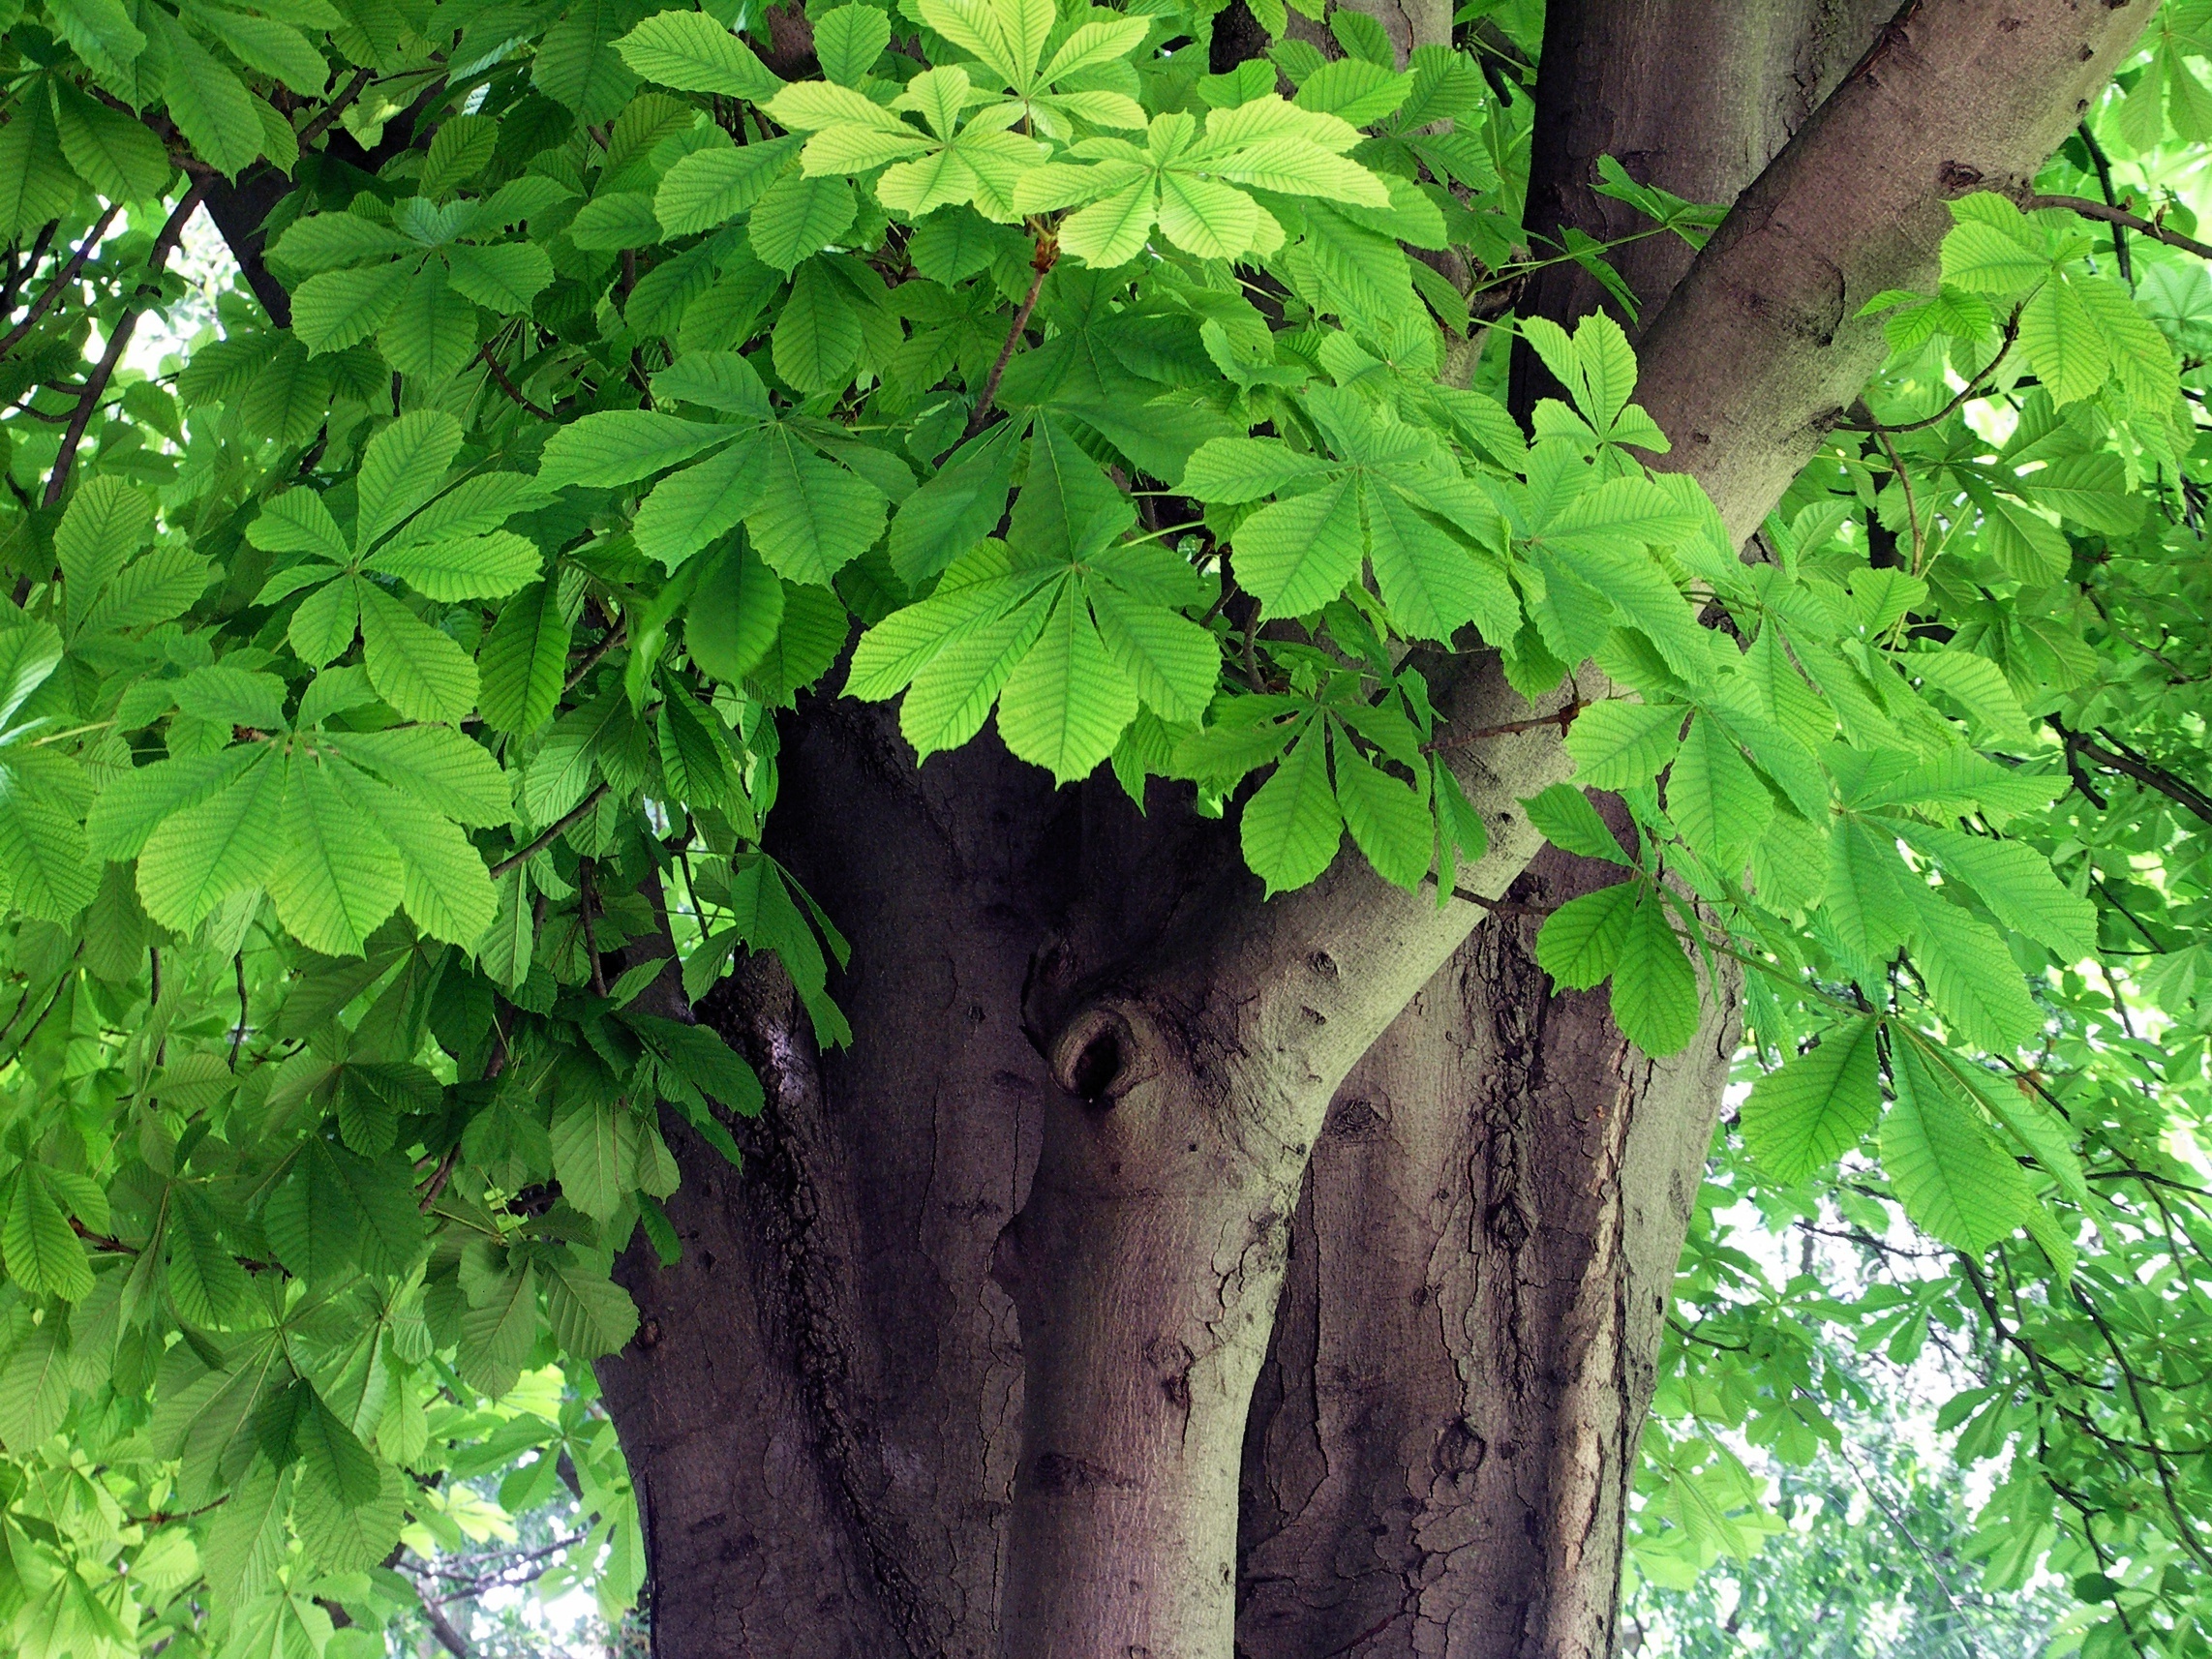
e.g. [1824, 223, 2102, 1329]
[602, 0, 2148, 1659]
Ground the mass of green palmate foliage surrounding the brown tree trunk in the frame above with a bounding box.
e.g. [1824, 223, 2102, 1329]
[0, 0, 2212, 1659]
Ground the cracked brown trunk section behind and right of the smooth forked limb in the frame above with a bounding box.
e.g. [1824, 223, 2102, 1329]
[1239, 852, 1739, 1659]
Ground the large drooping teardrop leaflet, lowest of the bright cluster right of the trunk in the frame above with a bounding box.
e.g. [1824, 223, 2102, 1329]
[1883, 1041, 2035, 1254]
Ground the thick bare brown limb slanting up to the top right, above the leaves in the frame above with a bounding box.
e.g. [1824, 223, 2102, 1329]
[1637, 0, 2157, 540]
